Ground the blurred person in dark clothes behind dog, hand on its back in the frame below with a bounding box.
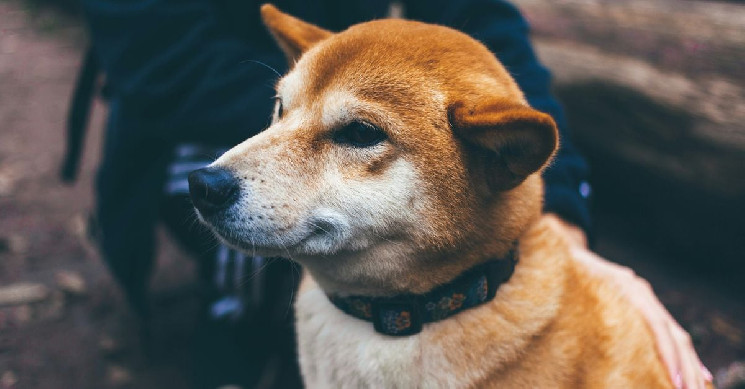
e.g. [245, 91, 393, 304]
[59, 0, 706, 388]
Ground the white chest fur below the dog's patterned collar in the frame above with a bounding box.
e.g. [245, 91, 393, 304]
[296, 287, 463, 388]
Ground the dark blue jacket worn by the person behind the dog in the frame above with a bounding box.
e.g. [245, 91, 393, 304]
[83, 0, 589, 312]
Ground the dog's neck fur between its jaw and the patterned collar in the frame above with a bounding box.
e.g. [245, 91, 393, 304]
[302, 176, 543, 297]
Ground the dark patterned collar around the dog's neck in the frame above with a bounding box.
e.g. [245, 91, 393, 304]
[329, 243, 518, 336]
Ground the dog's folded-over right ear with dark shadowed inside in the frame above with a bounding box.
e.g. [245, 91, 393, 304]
[449, 99, 559, 192]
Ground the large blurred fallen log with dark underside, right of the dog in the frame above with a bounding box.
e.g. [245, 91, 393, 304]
[515, 0, 745, 266]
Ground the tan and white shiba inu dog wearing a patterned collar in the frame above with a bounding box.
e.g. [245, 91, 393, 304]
[190, 5, 684, 388]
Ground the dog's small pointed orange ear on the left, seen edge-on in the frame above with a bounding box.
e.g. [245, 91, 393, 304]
[261, 4, 333, 64]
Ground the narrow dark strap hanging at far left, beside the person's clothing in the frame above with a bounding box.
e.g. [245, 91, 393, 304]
[60, 46, 99, 182]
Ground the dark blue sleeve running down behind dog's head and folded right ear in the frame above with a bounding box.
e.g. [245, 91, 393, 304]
[406, 0, 590, 233]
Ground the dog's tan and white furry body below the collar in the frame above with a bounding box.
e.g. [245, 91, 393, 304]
[297, 219, 672, 388]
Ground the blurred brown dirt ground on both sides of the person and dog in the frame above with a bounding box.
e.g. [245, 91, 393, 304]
[0, 0, 745, 388]
